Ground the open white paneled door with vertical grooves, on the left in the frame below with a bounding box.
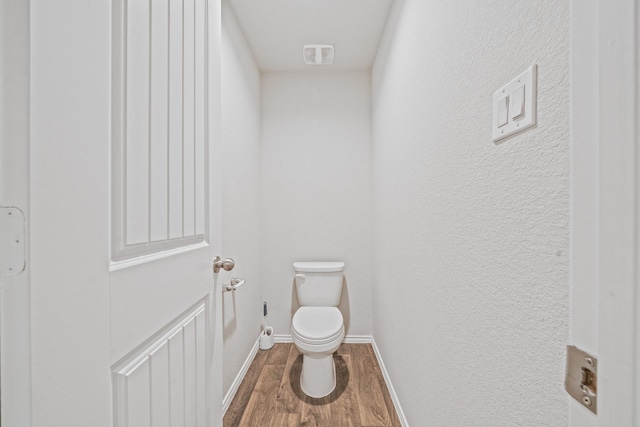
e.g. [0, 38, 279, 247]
[0, 0, 226, 427]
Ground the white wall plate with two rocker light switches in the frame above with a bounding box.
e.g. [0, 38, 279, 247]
[492, 65, 538, 142]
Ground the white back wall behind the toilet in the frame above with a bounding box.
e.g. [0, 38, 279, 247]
[261, 71, 373, 335]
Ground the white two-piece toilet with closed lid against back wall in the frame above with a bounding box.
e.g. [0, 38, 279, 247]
[291, 262, 344, 397]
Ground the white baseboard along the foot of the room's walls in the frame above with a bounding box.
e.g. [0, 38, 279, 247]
[222, 334, 409, 427]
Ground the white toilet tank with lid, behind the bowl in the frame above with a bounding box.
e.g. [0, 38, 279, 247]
[293, 262, 344, 307]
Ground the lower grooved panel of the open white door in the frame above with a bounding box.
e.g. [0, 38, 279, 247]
[113, 299, 208, 427]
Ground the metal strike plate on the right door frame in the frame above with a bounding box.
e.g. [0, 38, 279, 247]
[564, 345, 598, 414]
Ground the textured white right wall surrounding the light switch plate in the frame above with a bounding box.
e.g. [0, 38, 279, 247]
[372, 0, 569, 427]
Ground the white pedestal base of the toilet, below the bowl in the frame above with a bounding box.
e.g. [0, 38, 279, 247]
[300, 354, 336, 398]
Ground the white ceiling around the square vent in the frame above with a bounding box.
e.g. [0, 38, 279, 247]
[230, 0, 391, 71]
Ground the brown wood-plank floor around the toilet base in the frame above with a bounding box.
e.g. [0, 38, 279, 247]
[224, 344, 401, 427]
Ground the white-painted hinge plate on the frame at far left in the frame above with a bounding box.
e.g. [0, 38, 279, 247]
[0, 206, 27, 277]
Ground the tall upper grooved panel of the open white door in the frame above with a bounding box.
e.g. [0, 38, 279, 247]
[112, 0, 209, 261]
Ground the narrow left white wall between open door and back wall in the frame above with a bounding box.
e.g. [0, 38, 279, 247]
[216, 1, 262, 393]
